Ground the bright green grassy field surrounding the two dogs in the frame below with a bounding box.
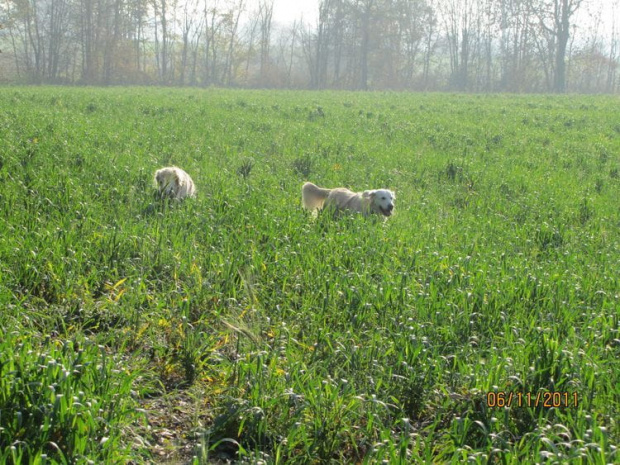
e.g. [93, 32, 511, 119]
[0, 88, 620, 464]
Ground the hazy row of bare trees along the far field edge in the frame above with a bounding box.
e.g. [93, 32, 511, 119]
[0, 0, 620, 93]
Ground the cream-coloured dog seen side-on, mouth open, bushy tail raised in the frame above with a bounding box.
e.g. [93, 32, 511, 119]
[301, 182, 396, 216]
